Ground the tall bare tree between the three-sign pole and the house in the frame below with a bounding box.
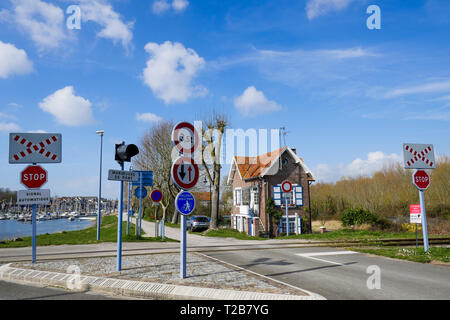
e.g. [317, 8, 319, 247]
[201, 112, 228, 229]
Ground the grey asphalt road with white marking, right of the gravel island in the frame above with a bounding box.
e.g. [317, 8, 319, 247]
[207, 247, 450, 300]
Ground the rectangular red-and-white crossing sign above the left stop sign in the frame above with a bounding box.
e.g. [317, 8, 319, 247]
[9, 133, 62, 163]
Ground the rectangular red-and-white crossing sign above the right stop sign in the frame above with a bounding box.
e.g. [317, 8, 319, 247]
[403, 143, 436, 169]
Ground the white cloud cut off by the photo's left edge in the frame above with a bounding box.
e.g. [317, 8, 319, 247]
[0, 41, 33, 79]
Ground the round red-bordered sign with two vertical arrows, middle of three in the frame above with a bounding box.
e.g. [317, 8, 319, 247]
[171, 157, 200, 190]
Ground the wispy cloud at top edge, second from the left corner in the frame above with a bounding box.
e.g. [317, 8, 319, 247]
[80, 0, 133, 49]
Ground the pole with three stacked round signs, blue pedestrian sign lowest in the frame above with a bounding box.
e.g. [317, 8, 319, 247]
[171, 122, 200, 279]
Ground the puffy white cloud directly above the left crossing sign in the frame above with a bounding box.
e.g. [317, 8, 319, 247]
[39, 86, 94, 126]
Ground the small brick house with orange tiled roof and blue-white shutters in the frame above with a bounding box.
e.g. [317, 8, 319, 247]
[228, 147, 315, 236]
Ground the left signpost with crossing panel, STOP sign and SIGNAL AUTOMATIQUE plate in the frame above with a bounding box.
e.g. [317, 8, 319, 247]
[9, 133, 62, 263]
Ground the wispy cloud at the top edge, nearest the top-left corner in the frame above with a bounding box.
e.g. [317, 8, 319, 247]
[11, 0, 67, 51]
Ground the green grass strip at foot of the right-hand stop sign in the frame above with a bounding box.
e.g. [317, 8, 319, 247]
[351, 247, 450, 263]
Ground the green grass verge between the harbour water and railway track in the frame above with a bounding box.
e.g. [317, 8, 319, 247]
[0, 216, 177, 248]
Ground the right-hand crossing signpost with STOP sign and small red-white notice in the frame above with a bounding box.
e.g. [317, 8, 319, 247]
[403, 143, 436, 252]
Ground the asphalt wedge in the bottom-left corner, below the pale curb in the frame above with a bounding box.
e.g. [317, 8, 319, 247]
[0, 281, 120, 300]
